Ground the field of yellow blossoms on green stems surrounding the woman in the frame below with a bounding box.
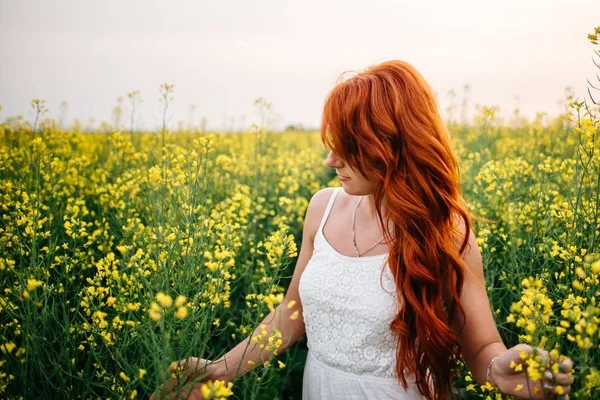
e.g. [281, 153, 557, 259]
[0, 31, 600, 399]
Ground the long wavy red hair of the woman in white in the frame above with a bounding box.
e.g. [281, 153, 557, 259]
[321, 61, 471, 399]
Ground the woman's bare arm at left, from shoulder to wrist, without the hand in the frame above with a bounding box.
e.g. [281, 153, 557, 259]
[205, 188, 331, 382]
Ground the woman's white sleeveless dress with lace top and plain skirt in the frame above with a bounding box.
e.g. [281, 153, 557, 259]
[298, 187, 425, 400]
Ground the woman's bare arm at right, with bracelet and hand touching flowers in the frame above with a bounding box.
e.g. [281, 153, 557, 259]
[445, 220, 574, 399]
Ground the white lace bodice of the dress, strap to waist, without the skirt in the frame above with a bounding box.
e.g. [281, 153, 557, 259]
[298, 188, 406, 378]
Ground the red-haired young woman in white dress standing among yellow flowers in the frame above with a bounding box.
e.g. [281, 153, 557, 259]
[152, 61, 573, 400]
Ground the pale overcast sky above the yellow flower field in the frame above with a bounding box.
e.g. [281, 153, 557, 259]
[0, 0, 600, 130]
